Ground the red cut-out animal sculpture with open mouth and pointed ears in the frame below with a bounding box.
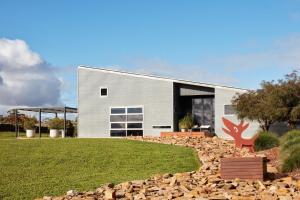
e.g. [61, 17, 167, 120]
[222, 117, 256, 152]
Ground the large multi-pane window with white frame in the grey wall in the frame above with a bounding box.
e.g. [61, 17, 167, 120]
[109, 106, 144, 137]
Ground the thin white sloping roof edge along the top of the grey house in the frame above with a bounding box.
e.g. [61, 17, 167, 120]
[78, 65, 248, 91]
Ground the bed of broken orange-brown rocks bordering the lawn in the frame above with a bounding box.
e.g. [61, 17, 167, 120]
[39, 137, 300, 200]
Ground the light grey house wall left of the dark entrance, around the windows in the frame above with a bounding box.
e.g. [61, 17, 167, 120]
[78, 67, 173, 137]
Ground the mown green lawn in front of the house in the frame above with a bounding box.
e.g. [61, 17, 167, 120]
[0, 139, 199, 199]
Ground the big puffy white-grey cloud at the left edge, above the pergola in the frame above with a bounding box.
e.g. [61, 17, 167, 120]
[0, 38, 61, 109]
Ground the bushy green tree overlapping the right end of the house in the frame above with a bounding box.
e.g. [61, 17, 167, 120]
[232, 71, 300, 131]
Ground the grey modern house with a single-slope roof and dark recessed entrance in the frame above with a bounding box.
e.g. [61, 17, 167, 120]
[78, 66, 258, 139]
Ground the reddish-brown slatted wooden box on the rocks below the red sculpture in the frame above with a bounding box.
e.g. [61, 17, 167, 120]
[221, 157, 267, 181]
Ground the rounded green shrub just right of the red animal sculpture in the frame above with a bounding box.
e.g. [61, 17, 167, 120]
[254, 131, 279, 151]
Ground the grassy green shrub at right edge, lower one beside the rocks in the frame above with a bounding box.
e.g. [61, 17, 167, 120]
[281, 146, 300, 172]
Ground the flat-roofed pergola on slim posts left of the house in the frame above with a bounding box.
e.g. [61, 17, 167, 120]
[9, 107, 77, 137]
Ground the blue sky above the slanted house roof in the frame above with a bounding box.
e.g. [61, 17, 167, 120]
[0, 0, 300, 111]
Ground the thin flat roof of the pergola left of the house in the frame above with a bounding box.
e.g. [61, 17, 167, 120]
[8, 107, 77, 113]
